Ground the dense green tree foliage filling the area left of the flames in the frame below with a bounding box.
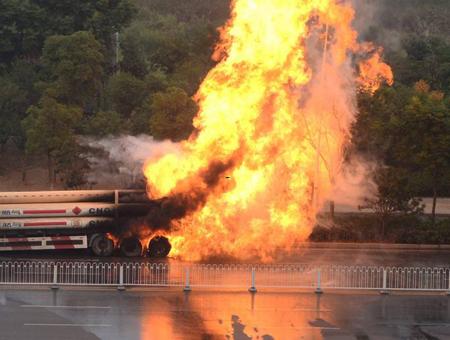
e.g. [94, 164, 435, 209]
[0, 0, 225, 187]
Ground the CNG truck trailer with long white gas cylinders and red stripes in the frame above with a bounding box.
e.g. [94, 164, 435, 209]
[0, 190, 171, 257]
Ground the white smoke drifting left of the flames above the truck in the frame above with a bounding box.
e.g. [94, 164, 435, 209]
[80, 135, 179, 189]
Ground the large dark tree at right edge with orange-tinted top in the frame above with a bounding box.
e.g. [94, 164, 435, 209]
[353, 81, 450, 223]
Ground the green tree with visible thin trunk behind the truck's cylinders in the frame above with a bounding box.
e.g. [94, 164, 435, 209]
[22, 95, 82, 188]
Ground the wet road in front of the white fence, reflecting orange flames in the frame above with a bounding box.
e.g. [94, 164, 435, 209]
[0, 289, 450, 340]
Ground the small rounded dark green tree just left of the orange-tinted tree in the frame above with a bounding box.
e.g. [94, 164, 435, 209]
[109, 72, 147, 117]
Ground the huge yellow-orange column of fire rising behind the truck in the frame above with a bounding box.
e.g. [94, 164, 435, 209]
[144, 0, 392, 261]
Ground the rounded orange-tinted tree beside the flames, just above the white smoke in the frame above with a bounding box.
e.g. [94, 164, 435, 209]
[150, 87, 197, 141]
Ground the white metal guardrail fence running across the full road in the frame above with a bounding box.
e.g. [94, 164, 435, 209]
[0, 261, 450, 293]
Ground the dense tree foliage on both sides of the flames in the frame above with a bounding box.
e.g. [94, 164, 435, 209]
[0, 0, 450, 234]
